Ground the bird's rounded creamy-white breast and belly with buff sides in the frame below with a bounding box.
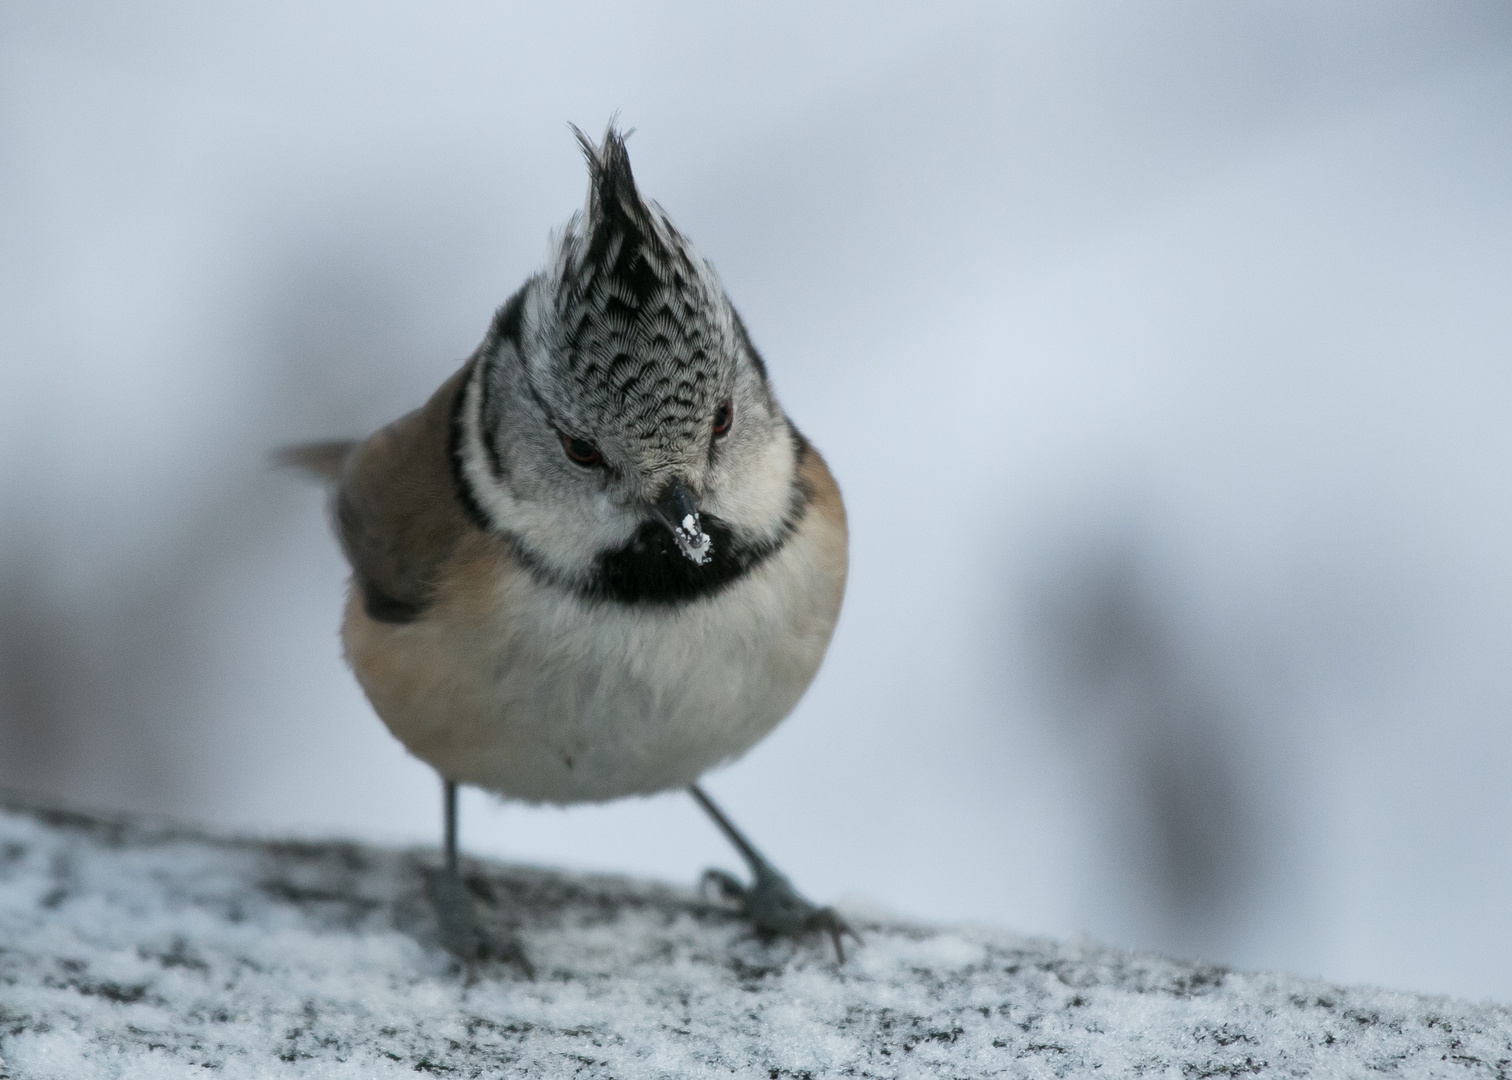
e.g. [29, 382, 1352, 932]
[345, 508, 845, 803]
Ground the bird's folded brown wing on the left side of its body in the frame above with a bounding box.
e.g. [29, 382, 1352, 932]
[336, 363, 476, 623]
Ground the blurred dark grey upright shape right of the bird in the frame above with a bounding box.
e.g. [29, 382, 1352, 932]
[1030, 534, 1279, 957]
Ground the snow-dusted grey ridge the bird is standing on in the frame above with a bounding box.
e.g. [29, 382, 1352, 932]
[0, 794, 1512, 1080]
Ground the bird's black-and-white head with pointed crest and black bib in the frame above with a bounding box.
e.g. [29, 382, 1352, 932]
[457, 126, 800, 602]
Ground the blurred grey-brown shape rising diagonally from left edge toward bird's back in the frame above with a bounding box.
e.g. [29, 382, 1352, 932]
[0, 253, 414, 817]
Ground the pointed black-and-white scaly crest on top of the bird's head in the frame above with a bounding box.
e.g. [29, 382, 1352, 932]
[534, 126, 742, 463]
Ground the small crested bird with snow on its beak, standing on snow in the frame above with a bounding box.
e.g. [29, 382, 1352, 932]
[278, 119, 860, 970]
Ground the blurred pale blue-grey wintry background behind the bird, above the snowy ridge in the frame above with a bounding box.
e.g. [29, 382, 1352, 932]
[0, 0, 1512, 1000]
